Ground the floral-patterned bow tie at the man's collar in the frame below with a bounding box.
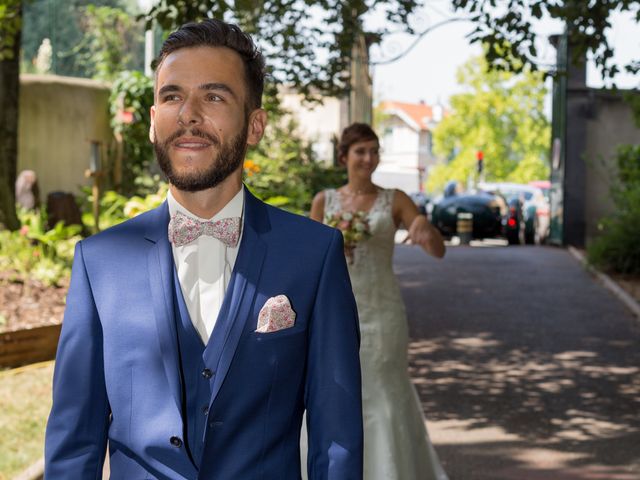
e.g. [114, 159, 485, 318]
[169, 212, 240, 247]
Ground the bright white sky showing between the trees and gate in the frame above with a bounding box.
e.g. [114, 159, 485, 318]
[370, 0, 640, 104]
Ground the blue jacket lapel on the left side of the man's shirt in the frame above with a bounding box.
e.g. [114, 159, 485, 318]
[145, 201, 182, 410]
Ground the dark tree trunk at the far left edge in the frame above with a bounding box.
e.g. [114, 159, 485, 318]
[0, 3, 22, 230]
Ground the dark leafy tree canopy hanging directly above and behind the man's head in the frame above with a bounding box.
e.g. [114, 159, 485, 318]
[146, 0, 421, 97]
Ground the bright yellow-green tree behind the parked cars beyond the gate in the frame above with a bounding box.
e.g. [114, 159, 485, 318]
[427, 57, 550, 191]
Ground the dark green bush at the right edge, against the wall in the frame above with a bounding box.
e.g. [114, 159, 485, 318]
[587, 145, 640, 275]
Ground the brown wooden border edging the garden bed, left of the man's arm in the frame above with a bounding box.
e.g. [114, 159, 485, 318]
[0, 324, 62, 368]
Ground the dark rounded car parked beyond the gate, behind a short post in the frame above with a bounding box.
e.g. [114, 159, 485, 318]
[430, 181, 508, 239]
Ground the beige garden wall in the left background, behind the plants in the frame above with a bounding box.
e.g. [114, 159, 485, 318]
[18, 74, 112, 201]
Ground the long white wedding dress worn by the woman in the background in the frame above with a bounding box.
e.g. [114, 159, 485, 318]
[302, 190, 448, 480]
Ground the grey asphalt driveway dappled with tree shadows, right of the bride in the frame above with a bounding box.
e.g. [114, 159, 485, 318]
[394, 246, 640, 480]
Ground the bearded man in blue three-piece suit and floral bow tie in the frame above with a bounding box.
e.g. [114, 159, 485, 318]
[45, 16, 362, 480]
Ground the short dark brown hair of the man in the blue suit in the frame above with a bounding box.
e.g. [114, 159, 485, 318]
[153, 19, 265, 109]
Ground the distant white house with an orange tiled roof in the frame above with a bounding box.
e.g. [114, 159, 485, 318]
[373, 101, 444, 193]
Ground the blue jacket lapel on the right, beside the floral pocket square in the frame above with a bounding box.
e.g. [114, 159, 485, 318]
[205, 188, 270, 403]
